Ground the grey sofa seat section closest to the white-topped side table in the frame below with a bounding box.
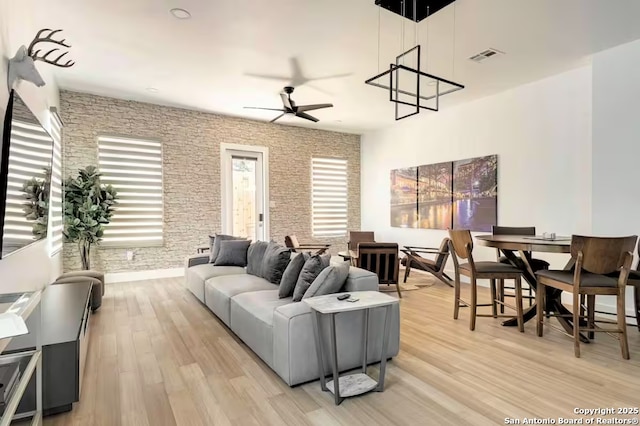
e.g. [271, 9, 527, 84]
[231, 290, 291, 368]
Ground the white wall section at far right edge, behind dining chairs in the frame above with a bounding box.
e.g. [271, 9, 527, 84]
[592, 40, 640, 318]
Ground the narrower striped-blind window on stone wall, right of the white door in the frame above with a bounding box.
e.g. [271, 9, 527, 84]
[311, 158, 347, 237]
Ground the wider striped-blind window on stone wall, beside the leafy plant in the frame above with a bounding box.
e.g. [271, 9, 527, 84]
[98, 136, 164, 247]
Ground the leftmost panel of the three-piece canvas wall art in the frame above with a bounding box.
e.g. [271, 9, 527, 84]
[391, 167, 418, 228]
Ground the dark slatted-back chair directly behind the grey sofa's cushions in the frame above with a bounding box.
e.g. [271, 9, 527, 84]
[355, 243, 402, 298]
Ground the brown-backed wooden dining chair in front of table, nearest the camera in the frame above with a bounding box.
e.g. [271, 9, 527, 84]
[536, 235, 638, 359]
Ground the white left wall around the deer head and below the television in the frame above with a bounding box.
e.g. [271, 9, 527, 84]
[0, 0, 62, 293]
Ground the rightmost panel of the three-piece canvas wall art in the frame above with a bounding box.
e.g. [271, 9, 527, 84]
[453, 155, 498, 232]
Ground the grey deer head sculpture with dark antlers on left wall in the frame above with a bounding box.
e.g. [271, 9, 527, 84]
[8, 28, 75, 90]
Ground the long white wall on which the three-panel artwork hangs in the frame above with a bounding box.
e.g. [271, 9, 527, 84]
[361, 67, 591, 267]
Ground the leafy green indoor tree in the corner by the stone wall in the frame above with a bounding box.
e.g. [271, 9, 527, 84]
[63, 166, 117, 270]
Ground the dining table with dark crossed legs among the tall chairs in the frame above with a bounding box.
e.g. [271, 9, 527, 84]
[475, 234, 589, 343]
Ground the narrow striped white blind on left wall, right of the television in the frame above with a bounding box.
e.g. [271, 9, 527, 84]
[49, 109, 64, 256]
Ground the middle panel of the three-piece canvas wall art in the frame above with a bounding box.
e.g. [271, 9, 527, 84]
[418, 161, 453, 229]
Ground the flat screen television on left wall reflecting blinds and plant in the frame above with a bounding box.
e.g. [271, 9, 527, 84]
[0, 90, 53, 258]
